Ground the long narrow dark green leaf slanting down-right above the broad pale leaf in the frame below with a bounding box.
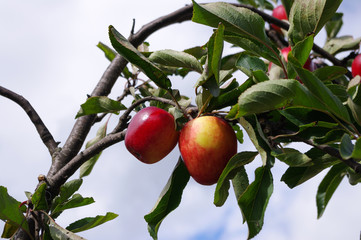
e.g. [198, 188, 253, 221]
[288, 53, 350, 121]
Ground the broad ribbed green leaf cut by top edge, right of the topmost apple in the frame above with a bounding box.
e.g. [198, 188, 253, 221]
[288, 0, 342, 45]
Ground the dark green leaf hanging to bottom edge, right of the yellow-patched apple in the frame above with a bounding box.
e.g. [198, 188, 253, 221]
[238, 166, 273, 239]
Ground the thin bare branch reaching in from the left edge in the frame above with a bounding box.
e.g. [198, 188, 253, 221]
[0, 86, 58, 155]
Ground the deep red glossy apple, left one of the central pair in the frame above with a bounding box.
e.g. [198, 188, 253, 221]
[125, 107, 179, 164]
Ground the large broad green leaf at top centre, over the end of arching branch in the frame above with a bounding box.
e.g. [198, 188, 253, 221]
[192, 1, 279, 64]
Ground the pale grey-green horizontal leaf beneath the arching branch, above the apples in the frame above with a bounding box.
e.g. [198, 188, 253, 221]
[148, 49, 203, 73]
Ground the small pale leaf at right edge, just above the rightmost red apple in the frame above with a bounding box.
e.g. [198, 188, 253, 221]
[323, 36, 361, 55]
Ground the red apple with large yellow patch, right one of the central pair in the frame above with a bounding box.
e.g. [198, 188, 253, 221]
[178, 116, 237, 185]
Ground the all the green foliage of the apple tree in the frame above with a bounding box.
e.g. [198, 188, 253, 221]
[0, 0, 361, 239]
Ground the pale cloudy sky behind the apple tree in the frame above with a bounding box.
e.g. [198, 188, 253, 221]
[0, 0, 361, 240]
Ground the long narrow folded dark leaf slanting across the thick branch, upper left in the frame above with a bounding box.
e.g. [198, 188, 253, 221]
[109, 26, 172, 89]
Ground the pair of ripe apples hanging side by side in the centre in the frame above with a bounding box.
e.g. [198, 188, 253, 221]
[125, 107, 237, 185]
